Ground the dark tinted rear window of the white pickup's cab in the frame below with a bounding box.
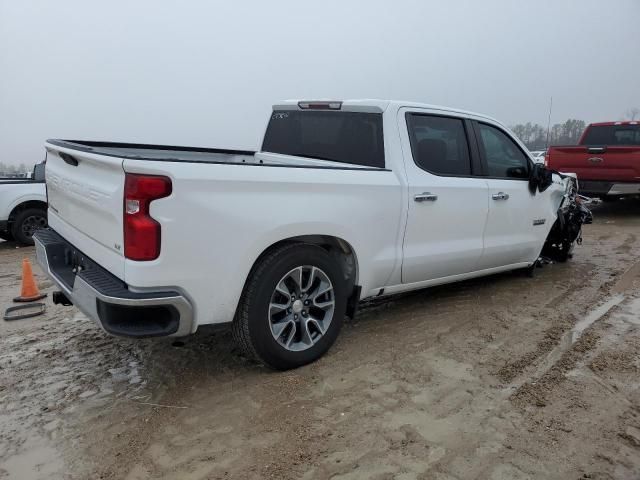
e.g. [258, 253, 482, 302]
[262, 110, 385, 168]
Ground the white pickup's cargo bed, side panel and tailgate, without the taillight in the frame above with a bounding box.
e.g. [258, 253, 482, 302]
[41, 135, 403, 328]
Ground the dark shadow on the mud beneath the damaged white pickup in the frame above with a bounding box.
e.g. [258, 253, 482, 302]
[116, 263, 579, 390]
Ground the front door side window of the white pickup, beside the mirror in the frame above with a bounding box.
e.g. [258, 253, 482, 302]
[477, 123, 529, 179]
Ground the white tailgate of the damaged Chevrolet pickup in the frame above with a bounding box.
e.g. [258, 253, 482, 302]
[46, 143, 125, 280]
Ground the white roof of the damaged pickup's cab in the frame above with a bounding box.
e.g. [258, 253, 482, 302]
[273, 98, 501, 124]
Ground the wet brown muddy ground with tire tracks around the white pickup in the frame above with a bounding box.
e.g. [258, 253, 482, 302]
[0, 197, 640, 480]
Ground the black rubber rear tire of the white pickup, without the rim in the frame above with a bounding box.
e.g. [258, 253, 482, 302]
[232, 243, 347, 370]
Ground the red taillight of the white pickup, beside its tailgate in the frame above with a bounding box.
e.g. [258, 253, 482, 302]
[124, 173, 171, 261]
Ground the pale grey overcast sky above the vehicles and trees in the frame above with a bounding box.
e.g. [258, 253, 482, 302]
[0, 0, 640, 163]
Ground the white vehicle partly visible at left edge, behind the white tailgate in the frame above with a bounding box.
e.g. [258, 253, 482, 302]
[0, 163, 47, 245]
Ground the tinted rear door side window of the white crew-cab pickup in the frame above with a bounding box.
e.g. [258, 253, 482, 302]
[407, 113, 471, 176]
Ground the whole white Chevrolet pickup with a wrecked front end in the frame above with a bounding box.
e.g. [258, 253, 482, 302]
[35, 100, 590, 369]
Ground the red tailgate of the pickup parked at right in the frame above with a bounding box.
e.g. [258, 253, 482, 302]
[549, 146, 640, 182]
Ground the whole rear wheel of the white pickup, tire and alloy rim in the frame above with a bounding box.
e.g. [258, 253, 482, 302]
[233, 244, 347, 370]
